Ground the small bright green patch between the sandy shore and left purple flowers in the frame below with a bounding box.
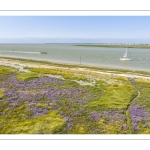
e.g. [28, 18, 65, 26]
[17, 72, 43, 81]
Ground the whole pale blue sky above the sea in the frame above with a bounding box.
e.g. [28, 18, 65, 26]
[0, 16, 150, 43]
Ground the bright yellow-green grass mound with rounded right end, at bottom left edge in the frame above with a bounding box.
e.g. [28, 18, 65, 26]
[1, 111, 65, 134]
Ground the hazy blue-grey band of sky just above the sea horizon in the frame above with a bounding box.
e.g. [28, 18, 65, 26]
[0, 37, 150, 44]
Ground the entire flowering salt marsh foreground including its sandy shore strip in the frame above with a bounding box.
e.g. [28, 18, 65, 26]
[0, 58, 150, 134]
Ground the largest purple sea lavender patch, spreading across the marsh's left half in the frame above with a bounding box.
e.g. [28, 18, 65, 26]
[0, 74, 99, 121]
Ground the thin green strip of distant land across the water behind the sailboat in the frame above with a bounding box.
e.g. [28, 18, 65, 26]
[75, 44, 150, 49]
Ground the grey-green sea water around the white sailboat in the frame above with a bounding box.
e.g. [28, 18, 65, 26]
[0, 44, 150, 71]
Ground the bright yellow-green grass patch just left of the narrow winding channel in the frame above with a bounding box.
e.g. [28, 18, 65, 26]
[88, 80, 137, 110]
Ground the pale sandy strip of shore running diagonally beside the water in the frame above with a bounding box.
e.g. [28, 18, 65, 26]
[0, 58, 150, 81]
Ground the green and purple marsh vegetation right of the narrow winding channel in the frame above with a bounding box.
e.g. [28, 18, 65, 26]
[126, 80, 150, 134]
